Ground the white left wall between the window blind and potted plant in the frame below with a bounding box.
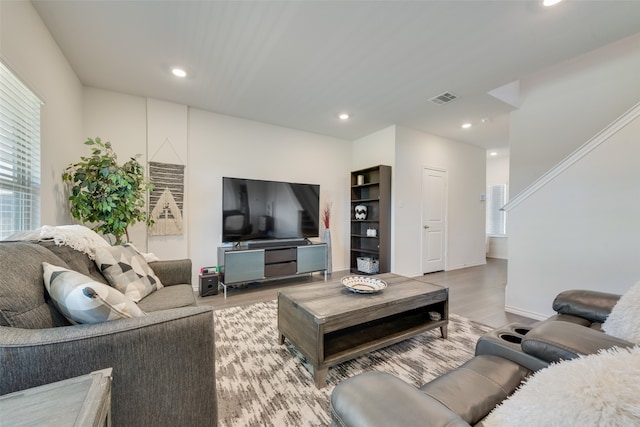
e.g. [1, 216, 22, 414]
[0, 1, 85, 225]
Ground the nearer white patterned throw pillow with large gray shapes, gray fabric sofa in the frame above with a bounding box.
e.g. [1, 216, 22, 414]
[42, 262, 146, 323]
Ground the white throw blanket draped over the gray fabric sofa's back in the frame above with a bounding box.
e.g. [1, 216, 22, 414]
[5, 225, 159, 262]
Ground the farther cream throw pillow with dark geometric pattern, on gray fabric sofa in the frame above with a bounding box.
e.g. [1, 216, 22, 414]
[96, 244, 162, 302]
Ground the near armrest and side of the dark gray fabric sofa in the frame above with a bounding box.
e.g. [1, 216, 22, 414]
[0, 307, 217, 426]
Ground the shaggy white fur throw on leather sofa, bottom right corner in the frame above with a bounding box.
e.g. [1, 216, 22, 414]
[483, 346, 640, 427]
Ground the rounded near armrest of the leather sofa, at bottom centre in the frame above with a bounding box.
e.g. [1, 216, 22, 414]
[330, 372, 469, 427]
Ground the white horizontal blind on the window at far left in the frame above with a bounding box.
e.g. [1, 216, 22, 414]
[0, 62, 42, 239]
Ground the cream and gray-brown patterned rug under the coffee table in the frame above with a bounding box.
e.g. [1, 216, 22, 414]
[215, 301, 491, 427]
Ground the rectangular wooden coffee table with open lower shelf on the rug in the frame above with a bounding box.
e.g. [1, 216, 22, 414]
[278, 273, 449, 388]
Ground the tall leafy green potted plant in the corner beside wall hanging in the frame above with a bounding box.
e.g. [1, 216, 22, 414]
[62, 137, 153, 245]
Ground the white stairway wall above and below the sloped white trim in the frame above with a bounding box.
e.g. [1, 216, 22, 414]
[506, 34, 640, 318]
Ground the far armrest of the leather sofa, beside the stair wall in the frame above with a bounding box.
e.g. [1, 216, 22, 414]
[553, 290, 620, 323]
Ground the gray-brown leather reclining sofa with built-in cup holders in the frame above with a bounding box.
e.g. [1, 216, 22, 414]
[330, 285, 640, 427]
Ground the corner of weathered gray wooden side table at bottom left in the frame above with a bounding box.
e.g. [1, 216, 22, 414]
[0, 368, 111, 427]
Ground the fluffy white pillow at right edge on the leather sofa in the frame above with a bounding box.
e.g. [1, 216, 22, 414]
[602, 282, 640, 344]
